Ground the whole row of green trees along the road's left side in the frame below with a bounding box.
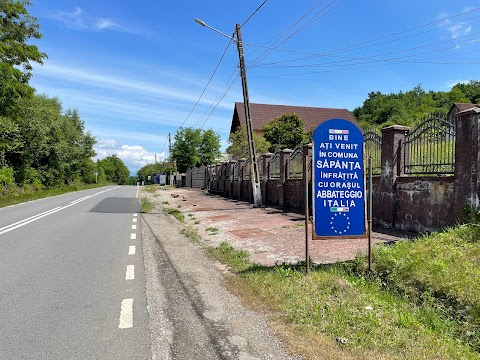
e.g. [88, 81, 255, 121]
[0, 0, 130, 194]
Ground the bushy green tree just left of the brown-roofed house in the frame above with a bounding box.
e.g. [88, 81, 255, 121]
[170, 128, 220, 172]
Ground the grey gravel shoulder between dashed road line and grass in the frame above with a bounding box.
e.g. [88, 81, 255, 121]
[142, 200, 291, 360]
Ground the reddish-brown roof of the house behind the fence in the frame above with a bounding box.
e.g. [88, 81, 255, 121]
[230, 102, 356, 136]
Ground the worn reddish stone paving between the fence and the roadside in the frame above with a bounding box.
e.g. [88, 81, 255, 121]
[155, 188, 413, 266]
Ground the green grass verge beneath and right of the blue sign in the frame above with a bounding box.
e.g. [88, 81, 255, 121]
[208, 224, 480, 359]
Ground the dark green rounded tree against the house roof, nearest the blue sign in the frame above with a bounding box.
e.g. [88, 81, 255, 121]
[263, 113, 306, 152]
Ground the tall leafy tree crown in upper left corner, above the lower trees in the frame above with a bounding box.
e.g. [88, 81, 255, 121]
[0, 0, 46, 116]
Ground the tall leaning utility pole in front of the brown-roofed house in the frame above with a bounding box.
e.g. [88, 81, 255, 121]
[235, 24, 262, 208]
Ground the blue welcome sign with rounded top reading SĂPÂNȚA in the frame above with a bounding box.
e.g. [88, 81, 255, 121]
[313, 119, 366, 237]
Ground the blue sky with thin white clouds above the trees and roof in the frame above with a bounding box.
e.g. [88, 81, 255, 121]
[29, 0, 480, 175]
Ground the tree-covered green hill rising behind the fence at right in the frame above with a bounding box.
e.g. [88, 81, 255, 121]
[353, 80, 480, 128]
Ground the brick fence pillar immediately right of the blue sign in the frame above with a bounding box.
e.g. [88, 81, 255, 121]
[372, 125, 410, 228]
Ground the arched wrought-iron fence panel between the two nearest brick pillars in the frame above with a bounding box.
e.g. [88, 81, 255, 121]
[404, 114, 456, 175]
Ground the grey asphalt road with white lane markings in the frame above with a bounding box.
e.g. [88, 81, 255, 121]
[0, 186, 151, 360]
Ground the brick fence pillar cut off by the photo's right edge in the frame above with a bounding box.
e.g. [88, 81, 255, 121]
[453, 109, 480, 220]
